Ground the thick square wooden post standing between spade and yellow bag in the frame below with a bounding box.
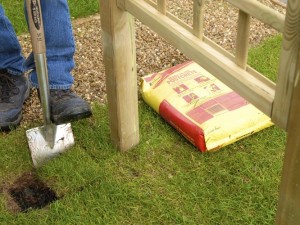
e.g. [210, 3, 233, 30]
[100, 0, 139, 151]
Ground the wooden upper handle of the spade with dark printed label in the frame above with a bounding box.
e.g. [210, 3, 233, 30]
[26, 0, 46, 54]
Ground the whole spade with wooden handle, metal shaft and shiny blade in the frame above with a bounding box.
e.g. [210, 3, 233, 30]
[26, 0, 74, 167]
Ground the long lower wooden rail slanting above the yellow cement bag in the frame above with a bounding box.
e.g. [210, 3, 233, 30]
[124, 0, 275, 116]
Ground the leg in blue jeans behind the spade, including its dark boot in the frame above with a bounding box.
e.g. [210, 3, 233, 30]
[27, 0, 91, 124]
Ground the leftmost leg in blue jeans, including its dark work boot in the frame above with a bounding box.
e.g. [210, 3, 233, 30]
[0, 4, 29, 130]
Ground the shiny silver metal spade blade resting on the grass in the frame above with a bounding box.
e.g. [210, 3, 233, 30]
[26, 123, 74, 167]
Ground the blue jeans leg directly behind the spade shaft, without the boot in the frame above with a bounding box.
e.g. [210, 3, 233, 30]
[26, 0, 75, 89]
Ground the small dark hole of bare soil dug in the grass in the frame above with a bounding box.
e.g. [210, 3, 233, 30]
[8, 172, 58, 212]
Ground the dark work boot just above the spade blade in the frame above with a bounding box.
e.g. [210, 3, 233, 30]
[45, 89, 92, 125]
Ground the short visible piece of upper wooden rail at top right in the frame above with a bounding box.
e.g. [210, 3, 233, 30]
[226, 0, 285, 33]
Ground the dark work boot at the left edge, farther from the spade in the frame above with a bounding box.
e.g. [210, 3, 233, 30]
[0, 70, 30, 131]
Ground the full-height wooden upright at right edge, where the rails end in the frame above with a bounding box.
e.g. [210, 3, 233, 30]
[274, 0, 300, 225]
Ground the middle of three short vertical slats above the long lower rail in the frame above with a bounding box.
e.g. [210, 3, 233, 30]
[193, 0, 205, 40]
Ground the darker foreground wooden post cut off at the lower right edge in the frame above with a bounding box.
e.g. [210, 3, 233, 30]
[276, 57, 300, 225]
